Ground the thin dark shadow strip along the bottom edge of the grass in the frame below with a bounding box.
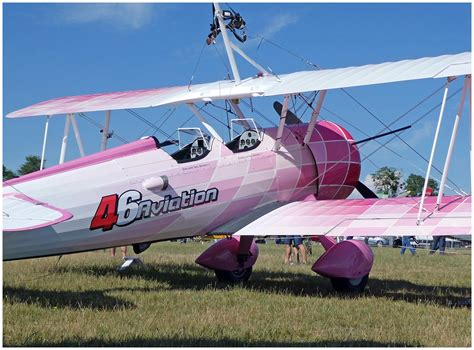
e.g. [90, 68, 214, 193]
[10, 338, 421, 347]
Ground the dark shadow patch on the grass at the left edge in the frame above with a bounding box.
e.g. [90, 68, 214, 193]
[3, 287, 136, 310]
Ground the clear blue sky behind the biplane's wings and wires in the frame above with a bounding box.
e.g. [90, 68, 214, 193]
[3, 3, 471, 193]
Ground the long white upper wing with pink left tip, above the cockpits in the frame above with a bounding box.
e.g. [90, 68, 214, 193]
[7, 52, 471, 118]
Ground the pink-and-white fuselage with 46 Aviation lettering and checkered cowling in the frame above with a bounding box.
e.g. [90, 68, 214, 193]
[3, 122, 360, 260]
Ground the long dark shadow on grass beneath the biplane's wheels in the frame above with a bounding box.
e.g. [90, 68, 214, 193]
[52, 264, 471, 307]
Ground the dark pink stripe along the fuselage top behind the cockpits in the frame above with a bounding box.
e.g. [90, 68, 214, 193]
[3, 137, 157, 186]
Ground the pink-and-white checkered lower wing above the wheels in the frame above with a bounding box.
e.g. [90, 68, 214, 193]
[236, 196, 471, 236]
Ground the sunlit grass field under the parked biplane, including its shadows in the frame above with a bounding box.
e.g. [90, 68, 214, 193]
[3, 243, 471, 347]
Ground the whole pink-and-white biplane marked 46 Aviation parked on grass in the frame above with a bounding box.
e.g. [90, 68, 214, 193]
[3, 4, 472, 292]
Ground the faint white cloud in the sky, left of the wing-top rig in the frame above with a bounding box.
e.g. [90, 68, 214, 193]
[62, 3, 153, 29]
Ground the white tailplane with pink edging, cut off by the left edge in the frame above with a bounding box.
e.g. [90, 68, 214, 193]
[3, 193, 72, 231]
